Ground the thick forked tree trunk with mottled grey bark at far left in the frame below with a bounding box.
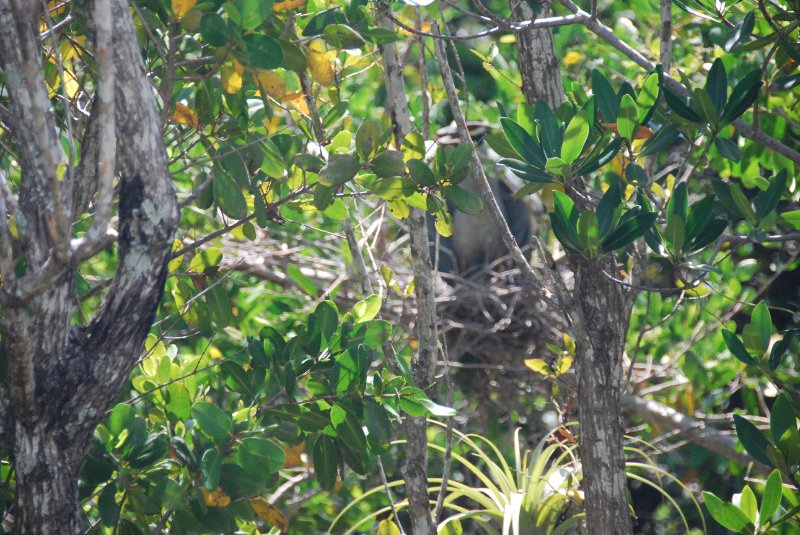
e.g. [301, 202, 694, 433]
[0, 0, 178, 534]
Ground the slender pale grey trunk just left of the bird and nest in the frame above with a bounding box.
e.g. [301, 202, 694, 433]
[376, 2, 438, 535]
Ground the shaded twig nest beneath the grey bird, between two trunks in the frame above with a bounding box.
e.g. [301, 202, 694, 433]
[437, 258, 563, 418]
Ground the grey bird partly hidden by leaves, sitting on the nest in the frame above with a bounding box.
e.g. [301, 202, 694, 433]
[428, 121, 533, 280]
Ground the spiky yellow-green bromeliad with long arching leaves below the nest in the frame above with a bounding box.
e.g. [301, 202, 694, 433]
[328, 421, 705, 535]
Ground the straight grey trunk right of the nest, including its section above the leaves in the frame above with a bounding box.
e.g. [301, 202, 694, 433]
[514, 4, 633, 535]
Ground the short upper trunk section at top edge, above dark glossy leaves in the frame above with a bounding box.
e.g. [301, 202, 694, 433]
[511, 2, 566, 109]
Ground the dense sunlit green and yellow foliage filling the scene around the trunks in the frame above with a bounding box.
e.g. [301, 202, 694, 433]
[0, 0, 800, 534]
